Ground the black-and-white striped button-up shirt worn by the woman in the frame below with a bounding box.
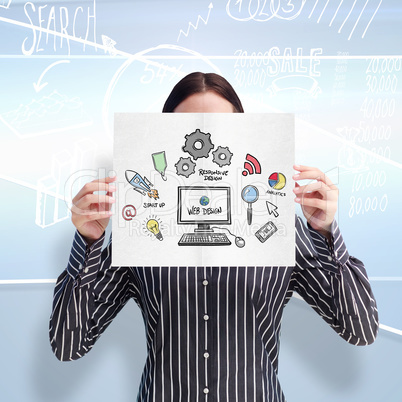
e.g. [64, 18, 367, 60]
[50, 217, 378, 402]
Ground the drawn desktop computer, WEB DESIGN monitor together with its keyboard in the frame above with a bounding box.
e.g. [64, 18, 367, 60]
[177, 186, 232, 246]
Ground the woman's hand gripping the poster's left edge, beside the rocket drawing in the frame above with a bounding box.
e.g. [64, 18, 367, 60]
[71, 176, 116, 245]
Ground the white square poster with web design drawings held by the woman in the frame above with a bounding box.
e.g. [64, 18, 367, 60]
[112, 113, 295, 266]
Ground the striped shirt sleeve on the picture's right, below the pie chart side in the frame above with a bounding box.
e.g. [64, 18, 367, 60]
[292, 217, 379, 345]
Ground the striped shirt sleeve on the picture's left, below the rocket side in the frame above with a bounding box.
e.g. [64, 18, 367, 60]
[49, 231, 136, 361]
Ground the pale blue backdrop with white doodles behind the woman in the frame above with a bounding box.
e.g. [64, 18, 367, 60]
[0, 0, 402, 402]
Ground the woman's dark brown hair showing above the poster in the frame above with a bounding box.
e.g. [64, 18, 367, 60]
[162, 72, 244, 113]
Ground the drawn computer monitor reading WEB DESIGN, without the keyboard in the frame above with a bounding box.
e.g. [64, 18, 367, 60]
[177, 186, 232, 232]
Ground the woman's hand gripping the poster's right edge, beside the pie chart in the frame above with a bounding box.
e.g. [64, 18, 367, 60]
[293, 165, 339, 239]
